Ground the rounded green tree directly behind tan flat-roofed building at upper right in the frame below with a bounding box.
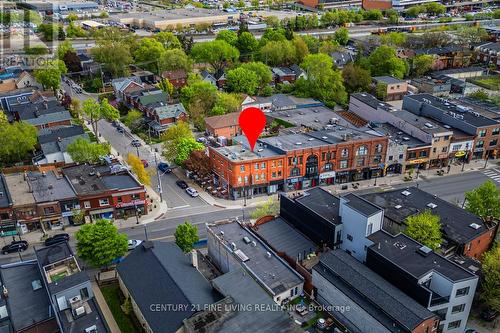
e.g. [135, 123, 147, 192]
[362, 45, 408, 79]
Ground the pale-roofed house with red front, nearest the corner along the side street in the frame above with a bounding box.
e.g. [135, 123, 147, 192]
[146, 102, 188, 136]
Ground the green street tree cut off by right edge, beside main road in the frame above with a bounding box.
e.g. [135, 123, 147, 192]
[465, 180, 500, 219]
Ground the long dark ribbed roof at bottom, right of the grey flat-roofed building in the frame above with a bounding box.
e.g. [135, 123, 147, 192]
[313, 249, 435, 332]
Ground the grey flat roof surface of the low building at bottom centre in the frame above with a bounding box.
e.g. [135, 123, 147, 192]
[207, 222, 304, 295]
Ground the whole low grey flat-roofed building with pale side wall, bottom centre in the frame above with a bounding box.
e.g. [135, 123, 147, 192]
[207, 221, 304, 305]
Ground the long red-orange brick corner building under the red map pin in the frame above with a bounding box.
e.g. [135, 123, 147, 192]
[209, 125, 388, 199]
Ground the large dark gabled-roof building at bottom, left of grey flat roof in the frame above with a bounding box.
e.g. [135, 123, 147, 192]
[116, 241, 222, 333]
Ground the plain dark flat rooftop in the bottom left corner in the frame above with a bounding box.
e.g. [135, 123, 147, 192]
[0, 261, 54, 332]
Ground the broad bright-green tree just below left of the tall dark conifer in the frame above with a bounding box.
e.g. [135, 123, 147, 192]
[191, 40, 240, 71]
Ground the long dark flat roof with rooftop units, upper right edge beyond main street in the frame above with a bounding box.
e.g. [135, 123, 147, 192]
[405, 94, 500, 127]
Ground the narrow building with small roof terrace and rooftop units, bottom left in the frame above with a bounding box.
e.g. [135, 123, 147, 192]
[34, 242, 110, 333]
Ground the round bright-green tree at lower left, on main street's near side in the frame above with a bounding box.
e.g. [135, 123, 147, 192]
[76, 220, 127, 267]
